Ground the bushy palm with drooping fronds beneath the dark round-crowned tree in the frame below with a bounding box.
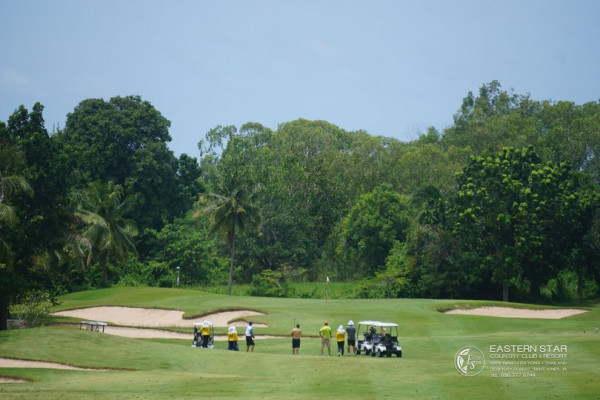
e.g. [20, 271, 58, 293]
[74, 181, 137, 285]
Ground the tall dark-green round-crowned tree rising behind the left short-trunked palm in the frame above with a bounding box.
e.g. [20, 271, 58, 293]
[57, 96, 192, 230]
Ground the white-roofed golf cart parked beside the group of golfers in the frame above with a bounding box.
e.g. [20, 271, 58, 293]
[356, 321, 402, 357]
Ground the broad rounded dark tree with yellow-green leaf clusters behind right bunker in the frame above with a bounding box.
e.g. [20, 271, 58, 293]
[448, 147, 592, 301]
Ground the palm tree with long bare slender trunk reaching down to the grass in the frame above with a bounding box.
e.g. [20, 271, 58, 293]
[193, 167, 258, 296]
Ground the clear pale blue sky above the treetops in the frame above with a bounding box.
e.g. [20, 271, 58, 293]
[0, 0, 600, 156]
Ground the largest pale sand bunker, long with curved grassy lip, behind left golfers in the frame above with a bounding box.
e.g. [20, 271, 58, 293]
[54, 306, 266, 327]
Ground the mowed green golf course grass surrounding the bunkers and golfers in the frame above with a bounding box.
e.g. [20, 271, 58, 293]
[0, 288, 600, 399]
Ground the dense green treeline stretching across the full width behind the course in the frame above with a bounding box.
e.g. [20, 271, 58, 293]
[0, 81, 600, 328]
